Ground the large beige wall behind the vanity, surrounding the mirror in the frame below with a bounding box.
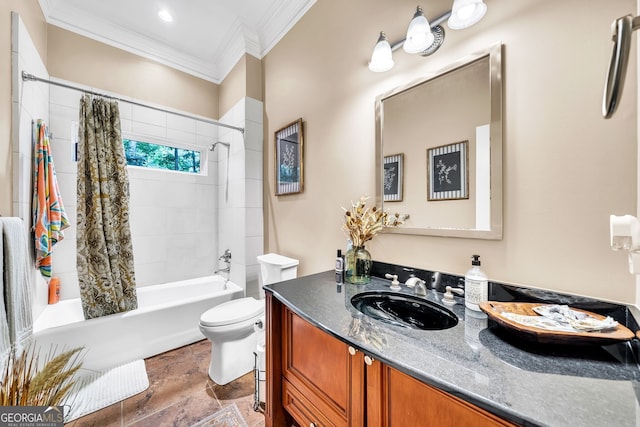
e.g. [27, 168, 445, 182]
[263, 0, 637, 302]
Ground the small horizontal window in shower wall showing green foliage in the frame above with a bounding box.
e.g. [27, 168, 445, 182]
[122, 139, 201, 173]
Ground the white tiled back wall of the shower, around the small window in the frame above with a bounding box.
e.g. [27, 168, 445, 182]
[50, 86, 218, 298]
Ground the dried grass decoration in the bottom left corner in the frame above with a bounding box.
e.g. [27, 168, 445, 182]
[0, 347, 83, 406]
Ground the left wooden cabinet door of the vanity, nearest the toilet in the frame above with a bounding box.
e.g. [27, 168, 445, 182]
[282, 308, 364, 426]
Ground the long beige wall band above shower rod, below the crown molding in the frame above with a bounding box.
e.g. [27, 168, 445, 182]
[47, 25, 219, 119]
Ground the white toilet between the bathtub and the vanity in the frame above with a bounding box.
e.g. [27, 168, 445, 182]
[200, 253, 299, 385]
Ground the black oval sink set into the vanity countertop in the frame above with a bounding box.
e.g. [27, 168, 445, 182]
[351, 292, 458, 331]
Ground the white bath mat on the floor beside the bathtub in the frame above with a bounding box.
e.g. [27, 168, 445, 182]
[65, 359, 149, 423]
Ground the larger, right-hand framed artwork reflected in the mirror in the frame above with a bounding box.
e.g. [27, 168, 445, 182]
[427, 141, 469, 201]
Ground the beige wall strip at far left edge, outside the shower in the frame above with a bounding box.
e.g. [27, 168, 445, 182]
[0, 0, 47, 216]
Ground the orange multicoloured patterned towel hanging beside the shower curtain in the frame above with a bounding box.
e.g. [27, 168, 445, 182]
[32, 120, 69, 277]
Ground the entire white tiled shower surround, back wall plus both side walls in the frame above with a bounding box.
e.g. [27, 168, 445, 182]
[14, 12, 264, 308]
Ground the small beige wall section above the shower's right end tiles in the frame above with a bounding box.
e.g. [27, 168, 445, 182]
[219, 54, 262, 114]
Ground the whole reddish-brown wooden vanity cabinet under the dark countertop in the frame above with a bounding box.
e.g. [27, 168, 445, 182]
[265, 293, 514, 427]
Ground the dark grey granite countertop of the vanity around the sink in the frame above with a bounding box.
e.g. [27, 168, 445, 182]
[265, 271, 640, 427]
